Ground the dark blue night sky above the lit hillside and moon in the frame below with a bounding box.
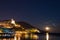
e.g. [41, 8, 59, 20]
[0, 0, 60, 31]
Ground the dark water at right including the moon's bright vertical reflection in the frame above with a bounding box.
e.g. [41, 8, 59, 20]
[38, 33, 60, 40]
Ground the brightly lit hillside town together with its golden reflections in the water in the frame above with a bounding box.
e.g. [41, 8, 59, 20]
[0, 19, 40, 40]
